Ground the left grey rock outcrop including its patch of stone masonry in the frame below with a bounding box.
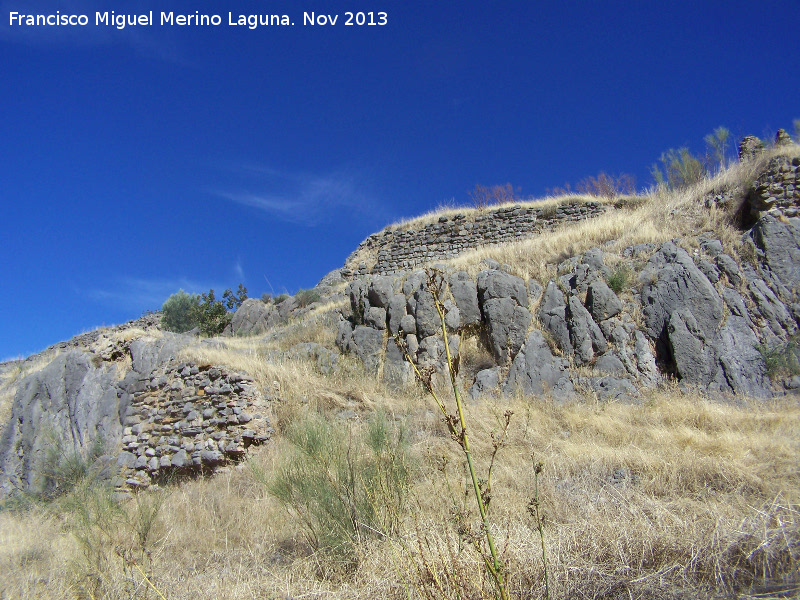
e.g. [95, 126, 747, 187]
[0, 328, 272, 496]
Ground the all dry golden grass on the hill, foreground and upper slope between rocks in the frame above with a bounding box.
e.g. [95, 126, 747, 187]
[0, 129, 800, 600]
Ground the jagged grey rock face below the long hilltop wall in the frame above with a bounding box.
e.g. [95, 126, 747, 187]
[339, 152, 800, 401]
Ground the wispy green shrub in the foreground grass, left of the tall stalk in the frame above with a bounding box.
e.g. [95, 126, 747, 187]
[266, 413, 410, 564]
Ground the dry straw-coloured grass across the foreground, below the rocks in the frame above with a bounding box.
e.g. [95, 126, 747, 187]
[0, 384, 800, 600]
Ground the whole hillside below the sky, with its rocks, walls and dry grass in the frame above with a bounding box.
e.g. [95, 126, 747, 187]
[0, 132, 800, 599]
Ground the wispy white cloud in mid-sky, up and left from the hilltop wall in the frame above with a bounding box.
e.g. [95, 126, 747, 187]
[211, 165, 384, 226]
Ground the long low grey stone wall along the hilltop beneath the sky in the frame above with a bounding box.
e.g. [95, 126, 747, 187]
[342, 202, 606, 277]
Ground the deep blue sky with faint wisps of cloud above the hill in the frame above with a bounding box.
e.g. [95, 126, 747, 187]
[0, 0, 800, 360]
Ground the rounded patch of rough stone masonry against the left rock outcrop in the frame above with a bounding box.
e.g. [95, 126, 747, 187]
[114, 363, 272, 491]
